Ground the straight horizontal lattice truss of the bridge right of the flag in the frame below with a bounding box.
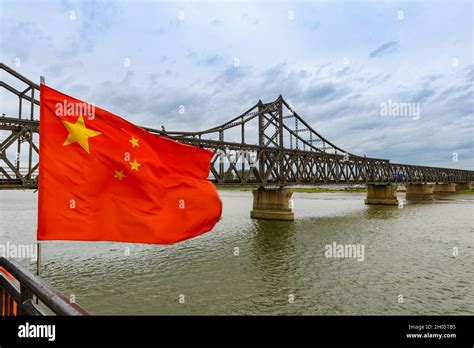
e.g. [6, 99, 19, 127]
[166, 136, 474, 185]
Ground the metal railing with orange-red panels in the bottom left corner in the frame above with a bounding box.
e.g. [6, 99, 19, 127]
[0, 257, 89, 316]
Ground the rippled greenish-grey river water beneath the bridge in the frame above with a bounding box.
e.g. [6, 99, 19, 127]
[0, 191, 474, 315]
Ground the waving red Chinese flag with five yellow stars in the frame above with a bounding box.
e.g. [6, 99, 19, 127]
[38, 85, 222, 244]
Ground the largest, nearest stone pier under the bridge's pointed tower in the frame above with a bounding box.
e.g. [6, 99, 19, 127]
[250, 187, 295, 221]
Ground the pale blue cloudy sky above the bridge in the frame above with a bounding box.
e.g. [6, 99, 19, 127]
[0, 0, 474, 169]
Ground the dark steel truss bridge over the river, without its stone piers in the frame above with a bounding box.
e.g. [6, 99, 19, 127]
[0, 63, 474, 189]
